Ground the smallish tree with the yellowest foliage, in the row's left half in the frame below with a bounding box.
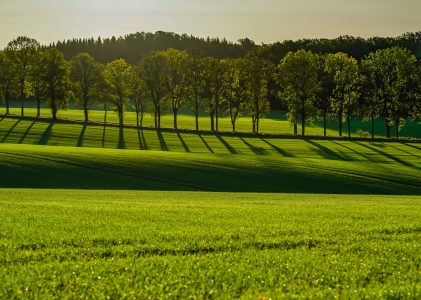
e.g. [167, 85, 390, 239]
[103, 58, 133, 127]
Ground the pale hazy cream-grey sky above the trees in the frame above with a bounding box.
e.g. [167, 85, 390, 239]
[0, 0, 421, 48]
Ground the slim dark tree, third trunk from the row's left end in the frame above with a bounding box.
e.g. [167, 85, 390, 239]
[27, 50, 47, 118]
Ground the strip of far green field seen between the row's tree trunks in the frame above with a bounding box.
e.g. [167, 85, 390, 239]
[1, 107, 421, 138]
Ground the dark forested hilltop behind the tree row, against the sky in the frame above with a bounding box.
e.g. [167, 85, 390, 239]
[51, 31, 421, 64]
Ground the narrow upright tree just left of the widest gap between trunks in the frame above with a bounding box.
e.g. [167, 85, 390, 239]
[243, 56, 274, 133]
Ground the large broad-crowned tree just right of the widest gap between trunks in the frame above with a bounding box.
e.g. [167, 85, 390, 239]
[276, 50, 320, 137]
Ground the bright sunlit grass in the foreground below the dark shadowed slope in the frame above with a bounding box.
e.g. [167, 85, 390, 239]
[0, 189, 421, 299]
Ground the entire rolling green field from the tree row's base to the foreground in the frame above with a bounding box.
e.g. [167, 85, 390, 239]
[0, 111, 421, 299]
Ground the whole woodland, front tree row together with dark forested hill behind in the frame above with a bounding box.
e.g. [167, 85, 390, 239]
[0, 32, 421, 139]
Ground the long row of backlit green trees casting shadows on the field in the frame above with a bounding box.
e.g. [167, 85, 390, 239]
[0, 37, 421, 137]
